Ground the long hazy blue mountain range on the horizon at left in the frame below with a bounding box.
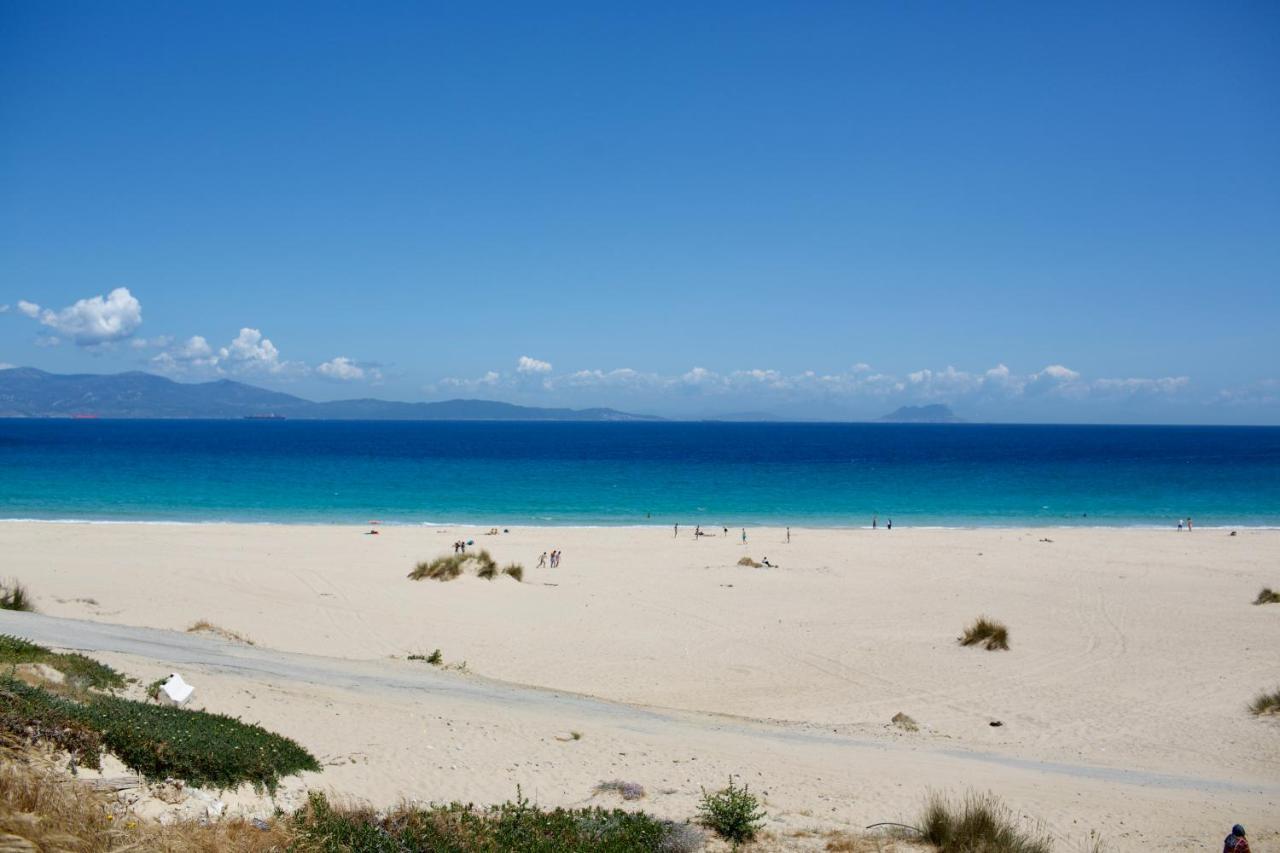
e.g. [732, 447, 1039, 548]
[0, 368, 660, 421]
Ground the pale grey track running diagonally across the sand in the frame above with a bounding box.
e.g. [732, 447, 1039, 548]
[0, 611, 1280, 794]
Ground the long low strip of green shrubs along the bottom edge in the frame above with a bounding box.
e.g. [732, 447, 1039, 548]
[291, 792, 700, 853]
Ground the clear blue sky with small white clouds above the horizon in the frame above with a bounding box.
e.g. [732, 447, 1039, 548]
[0, 1, 1280, 423]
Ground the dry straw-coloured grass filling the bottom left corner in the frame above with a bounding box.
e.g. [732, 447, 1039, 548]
[0, 742, 291, 853]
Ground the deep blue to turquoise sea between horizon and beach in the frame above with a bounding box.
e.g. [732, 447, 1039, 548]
[0, 420, 1280, 526]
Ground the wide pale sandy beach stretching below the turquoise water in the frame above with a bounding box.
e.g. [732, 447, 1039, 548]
[0, 523, 1280, 850]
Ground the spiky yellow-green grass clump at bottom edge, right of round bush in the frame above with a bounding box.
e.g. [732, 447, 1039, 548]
[919, 794, 1052, 853]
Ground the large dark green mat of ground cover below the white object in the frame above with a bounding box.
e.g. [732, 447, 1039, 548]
[0, 679, 320, 792]
